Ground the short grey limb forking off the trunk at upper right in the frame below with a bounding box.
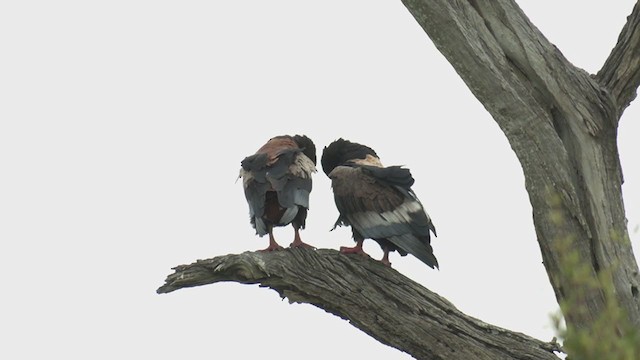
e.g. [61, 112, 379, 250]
[596, 1, 640, 114]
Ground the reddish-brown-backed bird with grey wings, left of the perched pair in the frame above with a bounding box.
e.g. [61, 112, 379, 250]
[238, 135, 317, 252]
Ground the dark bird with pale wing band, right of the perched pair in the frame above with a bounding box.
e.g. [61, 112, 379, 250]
[321, 138, 439, 269]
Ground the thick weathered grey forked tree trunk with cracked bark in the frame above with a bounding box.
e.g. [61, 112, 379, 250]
[403, 0, 640, 329]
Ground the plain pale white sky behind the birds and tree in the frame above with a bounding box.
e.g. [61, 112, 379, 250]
[0, 0, 640, 359]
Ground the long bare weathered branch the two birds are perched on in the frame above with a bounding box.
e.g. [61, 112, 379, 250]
[157, 249, 561, 360]
